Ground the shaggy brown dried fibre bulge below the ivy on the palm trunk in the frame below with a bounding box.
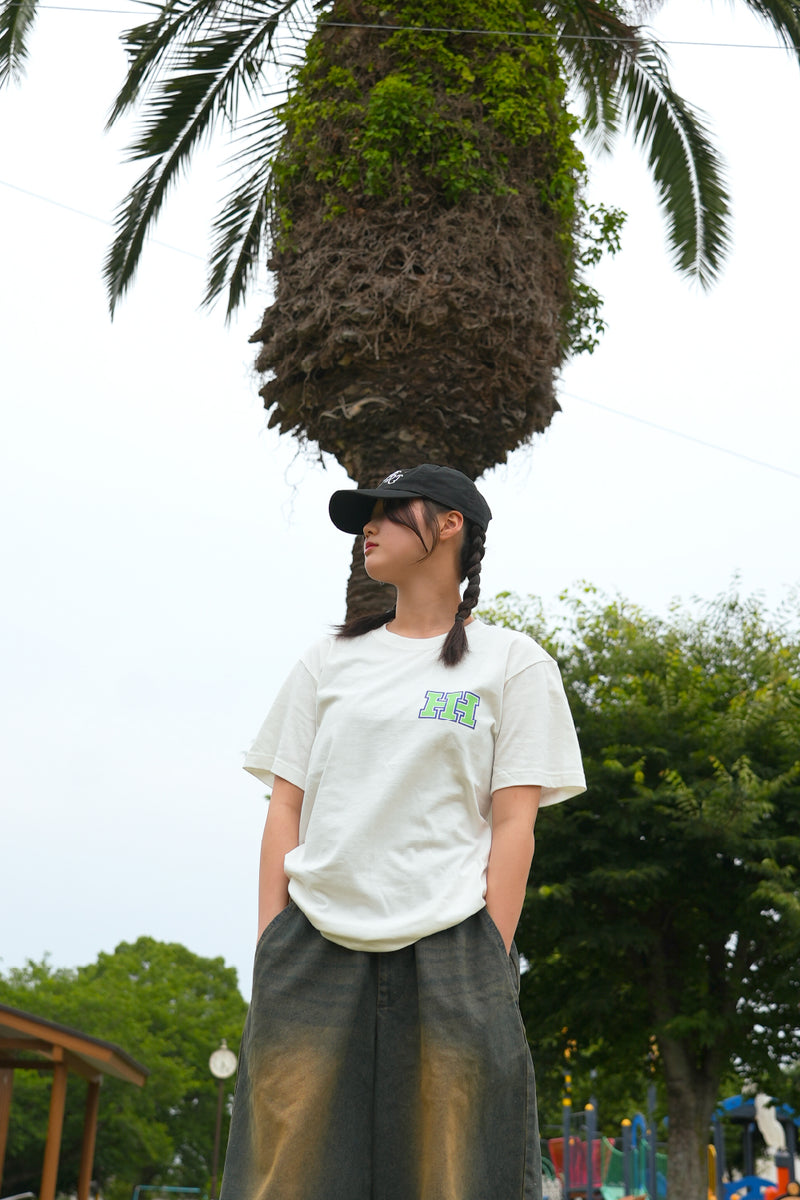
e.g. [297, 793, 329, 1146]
[257, 189, 564, 482]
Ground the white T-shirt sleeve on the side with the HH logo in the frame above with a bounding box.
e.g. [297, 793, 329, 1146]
[492, 658, 587, 805]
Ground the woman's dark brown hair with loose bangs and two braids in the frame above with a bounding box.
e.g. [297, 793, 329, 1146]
[336, 499, 486, 667]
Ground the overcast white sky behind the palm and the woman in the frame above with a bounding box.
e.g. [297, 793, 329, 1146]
[0, 0, 800, 995]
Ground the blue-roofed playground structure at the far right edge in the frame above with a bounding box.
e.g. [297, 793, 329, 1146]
[709, 1096, 800, 1200]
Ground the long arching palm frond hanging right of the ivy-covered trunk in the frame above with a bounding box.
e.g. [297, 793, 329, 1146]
[619, 41, 730, 288]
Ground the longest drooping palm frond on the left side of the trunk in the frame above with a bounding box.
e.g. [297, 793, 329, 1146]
[104, 6, 296, 314]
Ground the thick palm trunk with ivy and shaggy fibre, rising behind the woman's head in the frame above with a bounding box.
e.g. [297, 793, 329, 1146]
[251, 9, 581, 618]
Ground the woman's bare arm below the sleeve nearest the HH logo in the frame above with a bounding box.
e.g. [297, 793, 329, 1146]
[486, 786, 542, 950]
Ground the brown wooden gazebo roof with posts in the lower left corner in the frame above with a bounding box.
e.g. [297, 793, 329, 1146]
[0, 1004, 149, 1200]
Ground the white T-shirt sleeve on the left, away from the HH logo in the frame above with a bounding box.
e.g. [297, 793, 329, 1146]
[245, 661, 317, 791]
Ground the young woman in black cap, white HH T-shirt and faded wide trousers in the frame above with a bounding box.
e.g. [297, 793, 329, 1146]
[222, 464, 585, 1200]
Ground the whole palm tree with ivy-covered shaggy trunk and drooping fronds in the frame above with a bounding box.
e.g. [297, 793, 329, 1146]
[6, 0, 800, 612]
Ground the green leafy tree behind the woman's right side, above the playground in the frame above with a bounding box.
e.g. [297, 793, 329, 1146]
[482, 590, 800, 1200]
